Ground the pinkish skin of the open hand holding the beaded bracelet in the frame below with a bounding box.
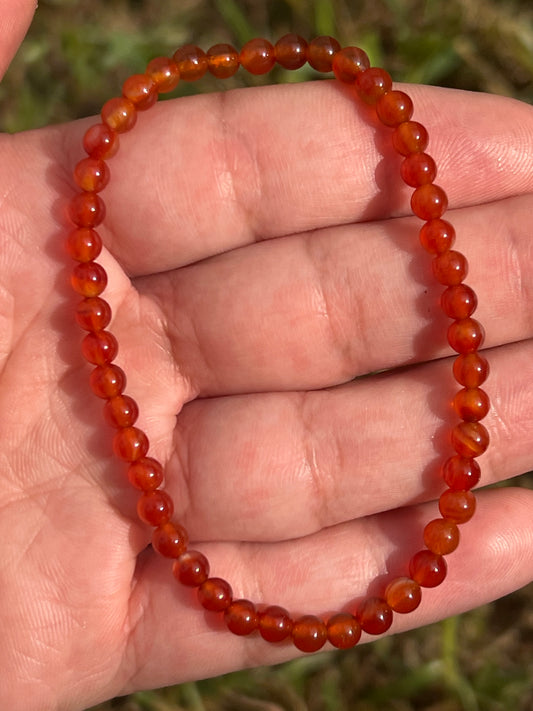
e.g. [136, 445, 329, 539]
[0, 0, 533, 711]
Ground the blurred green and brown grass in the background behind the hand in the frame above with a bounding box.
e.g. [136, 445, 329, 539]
[0, 0, 533, 711]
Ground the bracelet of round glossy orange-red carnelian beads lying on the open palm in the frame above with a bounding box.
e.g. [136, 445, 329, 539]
[67, 34, 489, 652]
